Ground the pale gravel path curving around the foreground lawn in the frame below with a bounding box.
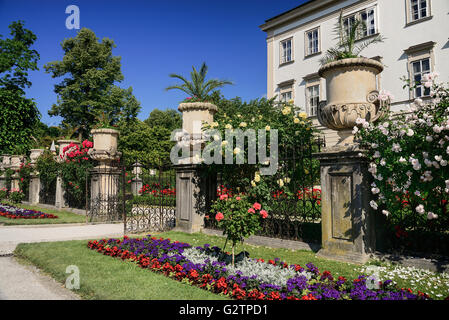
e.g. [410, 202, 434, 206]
[0, 224, 123, 300]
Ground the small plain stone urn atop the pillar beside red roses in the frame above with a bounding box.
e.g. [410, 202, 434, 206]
[89, 128, 121, 162]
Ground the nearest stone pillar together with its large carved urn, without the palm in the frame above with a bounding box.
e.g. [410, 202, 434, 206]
[316, 58, 389, 263]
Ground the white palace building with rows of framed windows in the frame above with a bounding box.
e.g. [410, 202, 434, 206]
[260, 0, 449, 145]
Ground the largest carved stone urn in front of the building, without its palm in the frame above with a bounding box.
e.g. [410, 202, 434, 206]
[317, 58, 384, 146]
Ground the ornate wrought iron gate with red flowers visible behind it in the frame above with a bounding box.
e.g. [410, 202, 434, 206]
[123, 162, 176, 233]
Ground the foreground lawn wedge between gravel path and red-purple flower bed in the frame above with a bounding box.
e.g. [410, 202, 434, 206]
[14, 240, 225, 300]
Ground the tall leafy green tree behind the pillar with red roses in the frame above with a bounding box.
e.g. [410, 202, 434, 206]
[44, 28, 140, 138]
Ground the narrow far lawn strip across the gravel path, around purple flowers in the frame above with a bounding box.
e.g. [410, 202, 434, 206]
[0, 201, 86, 226]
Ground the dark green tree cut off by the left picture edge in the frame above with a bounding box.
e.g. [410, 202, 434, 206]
[0, 21, 40, 153]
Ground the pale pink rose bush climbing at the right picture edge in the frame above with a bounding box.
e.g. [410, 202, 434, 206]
[354, 73, 449, 253]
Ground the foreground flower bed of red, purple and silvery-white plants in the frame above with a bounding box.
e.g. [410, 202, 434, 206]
[88, 236, 430, 300]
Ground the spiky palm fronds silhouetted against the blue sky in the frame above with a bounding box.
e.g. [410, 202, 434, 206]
[165, 62, 233, 101]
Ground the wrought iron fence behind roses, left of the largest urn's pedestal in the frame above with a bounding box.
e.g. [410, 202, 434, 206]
[205, 139, 325, 242]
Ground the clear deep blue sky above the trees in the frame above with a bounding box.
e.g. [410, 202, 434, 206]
[0, 0, 305, 125]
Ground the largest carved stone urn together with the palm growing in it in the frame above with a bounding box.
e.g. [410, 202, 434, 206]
[317, 13, 389, 146]
